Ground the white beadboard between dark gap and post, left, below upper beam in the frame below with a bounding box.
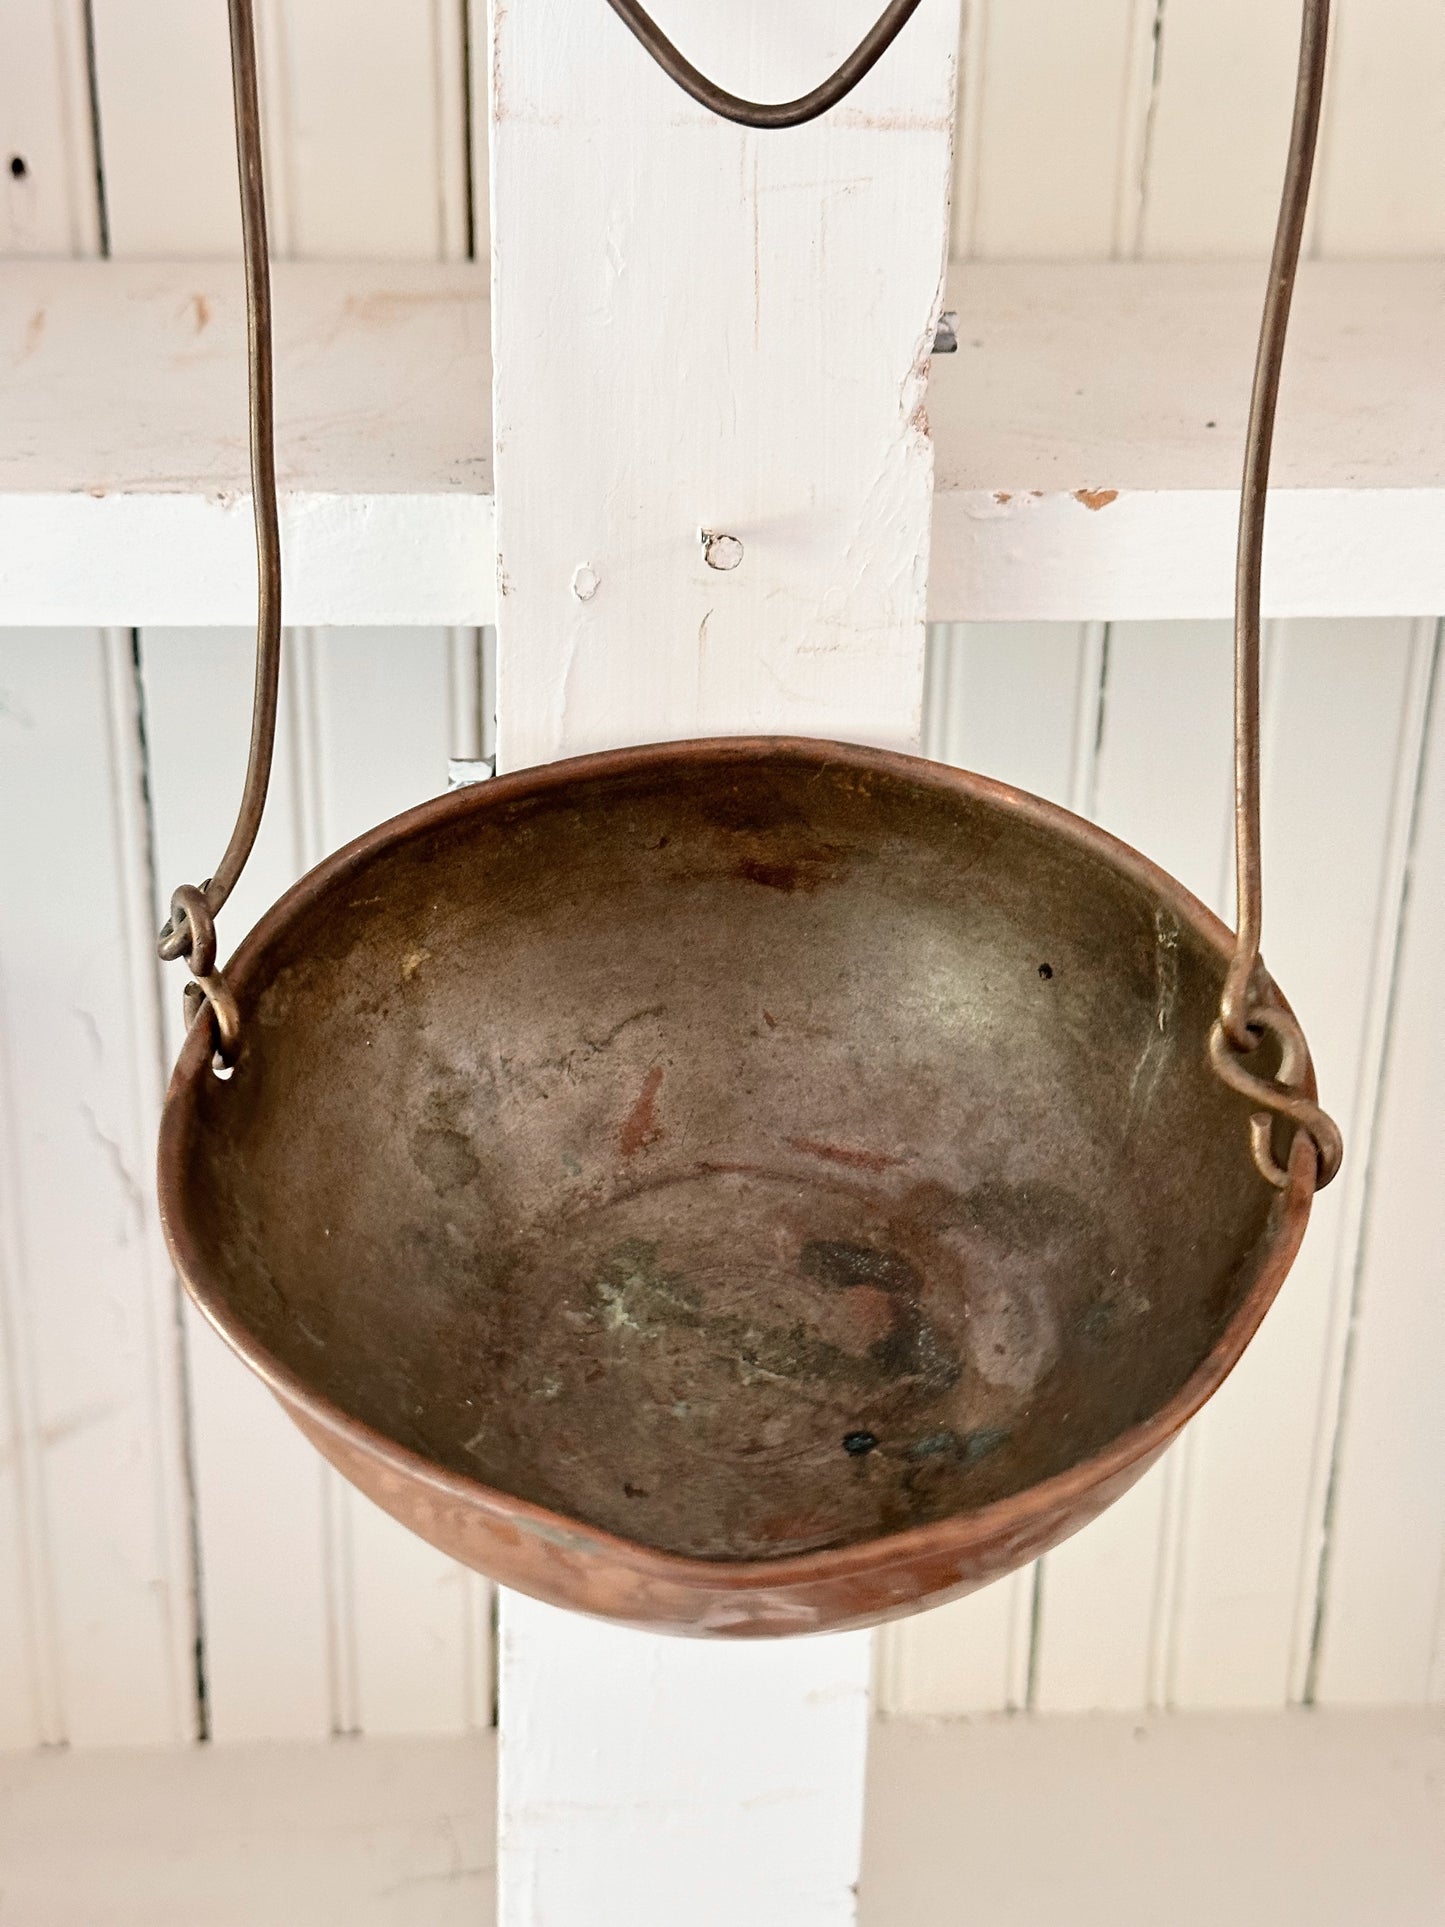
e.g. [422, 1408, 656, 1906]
[143, 630, 489, 1740]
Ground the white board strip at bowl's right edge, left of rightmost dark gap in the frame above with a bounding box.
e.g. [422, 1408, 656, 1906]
[1169, 622, 1428, 1705]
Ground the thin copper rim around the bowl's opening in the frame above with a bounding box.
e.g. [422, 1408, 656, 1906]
[158, 736, 1316, 1594]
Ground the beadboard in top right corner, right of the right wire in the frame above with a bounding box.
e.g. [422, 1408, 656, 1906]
[1316, 0, 1445, 256]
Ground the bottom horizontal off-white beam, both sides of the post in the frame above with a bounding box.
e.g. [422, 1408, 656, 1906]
[0, 1711, 1445, 1927]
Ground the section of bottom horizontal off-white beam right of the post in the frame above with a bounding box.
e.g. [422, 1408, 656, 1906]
[859, 1713, 1445, 1927]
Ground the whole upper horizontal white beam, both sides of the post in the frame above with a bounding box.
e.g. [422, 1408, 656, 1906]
[0, 260, 1445, 624]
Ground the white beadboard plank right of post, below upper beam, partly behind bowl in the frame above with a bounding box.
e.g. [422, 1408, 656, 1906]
[879, 622, 1098, 1713]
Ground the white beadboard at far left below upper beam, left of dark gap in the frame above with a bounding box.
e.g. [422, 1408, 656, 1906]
[0, 632, 195, 1744]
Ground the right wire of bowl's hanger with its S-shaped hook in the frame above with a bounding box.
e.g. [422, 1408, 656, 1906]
[1210, 0, 1343, 1189]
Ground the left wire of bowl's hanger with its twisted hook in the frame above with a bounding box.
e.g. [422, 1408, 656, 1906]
[156, 0, 281, 1064]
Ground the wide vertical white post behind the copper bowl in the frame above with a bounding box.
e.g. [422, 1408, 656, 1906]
[491, 0, 958, 1927]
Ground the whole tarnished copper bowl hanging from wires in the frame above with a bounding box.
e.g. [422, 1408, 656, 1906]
[160, 740, 1312, 1634]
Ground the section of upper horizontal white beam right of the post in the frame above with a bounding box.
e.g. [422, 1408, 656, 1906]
[929, 262, 1445, 620]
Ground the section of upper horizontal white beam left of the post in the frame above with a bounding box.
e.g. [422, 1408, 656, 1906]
[0, 260, 495, 628]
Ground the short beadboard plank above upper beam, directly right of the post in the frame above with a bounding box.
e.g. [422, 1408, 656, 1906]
[954, 0, 1152, 260]
